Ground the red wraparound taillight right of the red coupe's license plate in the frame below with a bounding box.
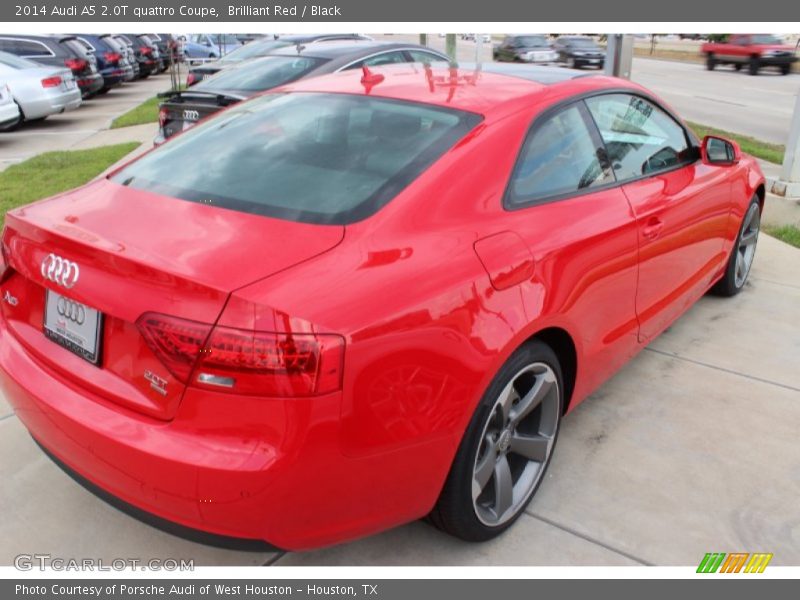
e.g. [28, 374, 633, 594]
[137, 313, 344, 397]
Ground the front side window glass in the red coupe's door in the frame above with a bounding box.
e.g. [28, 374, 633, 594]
[586, 94, 692, 180]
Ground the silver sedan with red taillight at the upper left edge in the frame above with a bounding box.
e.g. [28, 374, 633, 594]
[0, 52, 81, 121]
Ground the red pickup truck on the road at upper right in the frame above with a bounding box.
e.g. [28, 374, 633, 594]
[700, 33, 797, 75]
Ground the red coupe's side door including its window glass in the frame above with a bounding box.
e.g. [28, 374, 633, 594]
[586, 93, 731, 342]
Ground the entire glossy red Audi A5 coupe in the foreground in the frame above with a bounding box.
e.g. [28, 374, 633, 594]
[0, 65, 764, 549]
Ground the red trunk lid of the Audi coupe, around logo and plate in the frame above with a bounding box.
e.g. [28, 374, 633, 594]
[0, 180, 344, 420]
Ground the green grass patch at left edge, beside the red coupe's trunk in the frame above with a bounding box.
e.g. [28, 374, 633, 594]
[0, 142, 139, 229]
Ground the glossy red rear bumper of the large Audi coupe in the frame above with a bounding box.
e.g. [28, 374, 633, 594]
[0, 317, 453, 550]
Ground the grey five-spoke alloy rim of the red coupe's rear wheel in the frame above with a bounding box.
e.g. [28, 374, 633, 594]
[472, 362, 560, 527]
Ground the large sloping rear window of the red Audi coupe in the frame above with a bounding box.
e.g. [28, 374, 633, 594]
[112, 93, 481, 224]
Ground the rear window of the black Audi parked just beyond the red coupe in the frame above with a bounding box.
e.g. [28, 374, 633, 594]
[197, 56, 326, 92]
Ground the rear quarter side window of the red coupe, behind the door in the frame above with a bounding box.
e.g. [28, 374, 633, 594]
[509, 104, 614, 204]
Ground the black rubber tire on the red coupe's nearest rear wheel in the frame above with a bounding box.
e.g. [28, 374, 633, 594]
[428, 340, 564, 542]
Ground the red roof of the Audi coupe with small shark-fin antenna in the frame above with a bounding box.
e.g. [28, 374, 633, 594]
[280, 63, 620, 119]
